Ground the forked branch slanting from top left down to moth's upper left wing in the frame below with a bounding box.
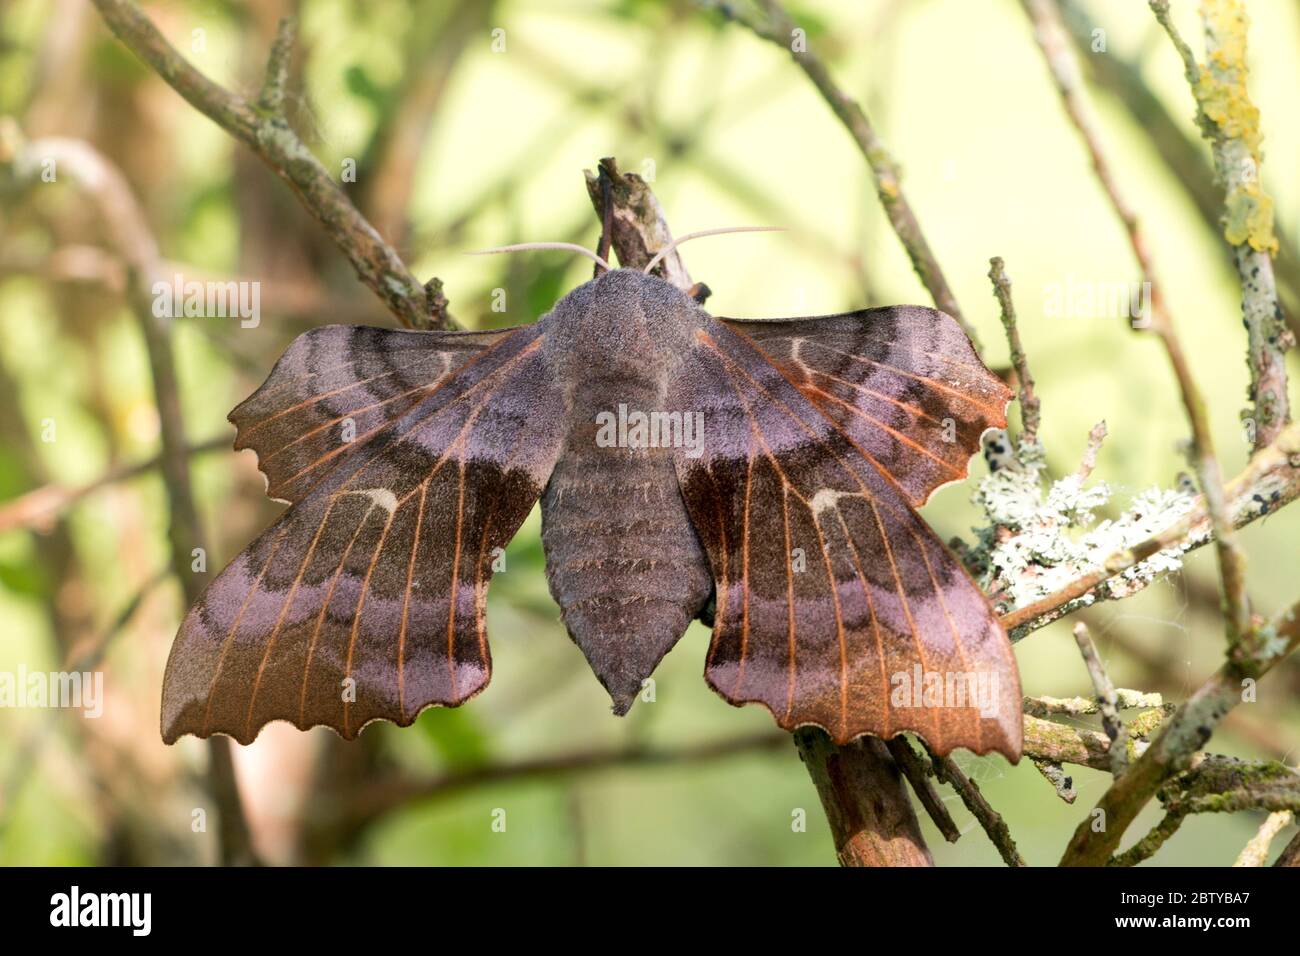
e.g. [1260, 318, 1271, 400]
[94, 0, 451, 329]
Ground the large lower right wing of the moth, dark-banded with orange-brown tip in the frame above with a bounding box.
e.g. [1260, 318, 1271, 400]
[675, 320, 1022, 760]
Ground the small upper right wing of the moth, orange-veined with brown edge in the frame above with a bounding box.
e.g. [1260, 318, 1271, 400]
[724, 312, 1011, 506]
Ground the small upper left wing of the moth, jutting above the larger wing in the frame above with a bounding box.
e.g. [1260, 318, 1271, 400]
[229, 325, 512, 502]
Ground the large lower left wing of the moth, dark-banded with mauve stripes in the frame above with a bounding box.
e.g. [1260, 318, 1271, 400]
[163, 326, 566, 743]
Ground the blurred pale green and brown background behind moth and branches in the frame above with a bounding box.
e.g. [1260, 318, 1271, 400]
[0, 0, 1300, 865]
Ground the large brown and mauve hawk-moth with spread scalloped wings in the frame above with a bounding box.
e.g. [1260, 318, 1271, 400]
[161, 239, 1022, 760]
